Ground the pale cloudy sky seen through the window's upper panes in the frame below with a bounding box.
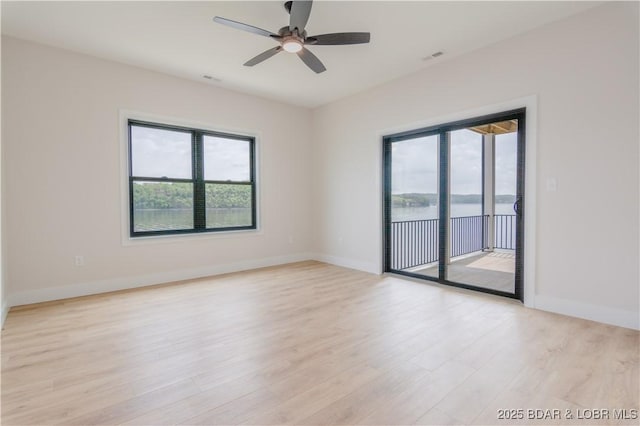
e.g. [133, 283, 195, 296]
[131, 126, 250, 181]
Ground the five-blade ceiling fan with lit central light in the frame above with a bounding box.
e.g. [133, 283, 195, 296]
[213, 0, 371, 73]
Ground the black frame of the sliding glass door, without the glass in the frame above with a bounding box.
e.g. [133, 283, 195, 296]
[382, 108, 526, 301]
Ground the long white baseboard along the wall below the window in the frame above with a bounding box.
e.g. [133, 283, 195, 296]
[7, 253, 313, 308]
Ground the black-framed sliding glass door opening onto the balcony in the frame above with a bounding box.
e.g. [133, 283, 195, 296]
[384, 110, 525, 299]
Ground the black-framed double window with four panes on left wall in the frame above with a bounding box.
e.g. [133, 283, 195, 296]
[128, 120, 256, 237]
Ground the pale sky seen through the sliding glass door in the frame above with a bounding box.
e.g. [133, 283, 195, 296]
[391, 129, 517, 194]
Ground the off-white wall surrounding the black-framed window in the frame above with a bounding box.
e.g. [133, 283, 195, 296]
[2, 37, 311, 305]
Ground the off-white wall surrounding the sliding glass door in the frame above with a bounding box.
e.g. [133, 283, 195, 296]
[313, 3, 640, 328]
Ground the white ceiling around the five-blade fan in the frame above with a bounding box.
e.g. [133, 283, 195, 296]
[2, 1, 598, 107]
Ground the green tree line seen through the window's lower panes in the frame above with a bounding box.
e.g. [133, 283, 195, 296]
[133, 182, 251, 210]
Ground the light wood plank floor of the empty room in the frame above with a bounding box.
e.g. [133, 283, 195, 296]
[1, 262, 640, 425]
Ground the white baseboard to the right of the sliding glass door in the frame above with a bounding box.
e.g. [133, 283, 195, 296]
[535, 295, 640, 330]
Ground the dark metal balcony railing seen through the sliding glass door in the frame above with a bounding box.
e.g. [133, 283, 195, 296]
[391, 215, 516, 270]
